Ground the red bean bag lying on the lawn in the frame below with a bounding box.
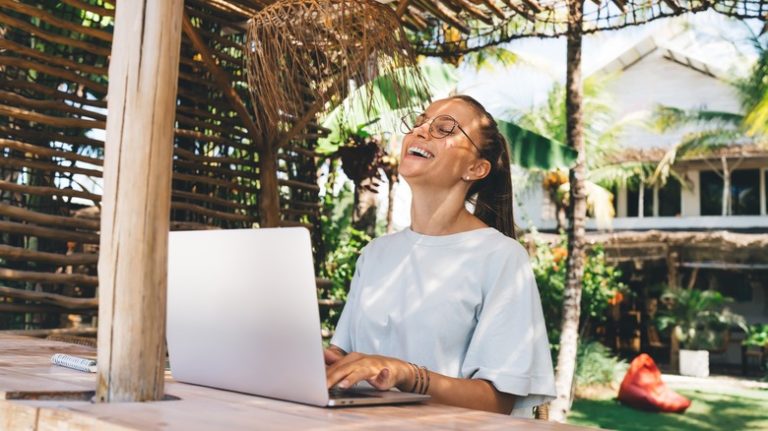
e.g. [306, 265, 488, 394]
[619, 353, 691, 413]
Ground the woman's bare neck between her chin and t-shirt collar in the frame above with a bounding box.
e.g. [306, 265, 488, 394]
[411, 184, 486, 235]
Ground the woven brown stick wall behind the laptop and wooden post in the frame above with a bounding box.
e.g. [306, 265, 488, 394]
[0, 0, 323, 329]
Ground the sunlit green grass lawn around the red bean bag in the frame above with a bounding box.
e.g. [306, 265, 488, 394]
[568, 389, 768, 431]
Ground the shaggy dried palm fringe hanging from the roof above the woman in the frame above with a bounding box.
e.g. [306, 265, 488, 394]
[246, 0, 428, 138]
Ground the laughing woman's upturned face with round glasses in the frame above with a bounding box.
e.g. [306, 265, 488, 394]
[399, 99, 482, 187]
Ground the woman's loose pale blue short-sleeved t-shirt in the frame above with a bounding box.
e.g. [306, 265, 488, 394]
[331, 228, 555, 417]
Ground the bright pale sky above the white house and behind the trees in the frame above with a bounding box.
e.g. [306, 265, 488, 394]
[450, 12, 762, 118]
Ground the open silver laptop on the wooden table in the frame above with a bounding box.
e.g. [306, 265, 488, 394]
[167, 228, 429, 406]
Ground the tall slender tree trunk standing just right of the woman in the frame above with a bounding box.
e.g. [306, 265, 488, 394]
[550, 0, 587, 422]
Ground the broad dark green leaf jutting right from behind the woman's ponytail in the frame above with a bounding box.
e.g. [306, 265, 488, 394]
[497, 120, 576, 170]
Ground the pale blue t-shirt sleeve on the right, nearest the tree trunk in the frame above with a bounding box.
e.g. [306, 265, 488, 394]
[461, 243, 556, 415]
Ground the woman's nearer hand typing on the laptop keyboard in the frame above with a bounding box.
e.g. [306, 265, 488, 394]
[325, 350, 413, 391]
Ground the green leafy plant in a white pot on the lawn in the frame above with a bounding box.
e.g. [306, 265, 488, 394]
[656, 288, 747, 377]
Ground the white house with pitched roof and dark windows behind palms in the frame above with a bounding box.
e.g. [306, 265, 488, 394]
[518, 33, 768, 236]
